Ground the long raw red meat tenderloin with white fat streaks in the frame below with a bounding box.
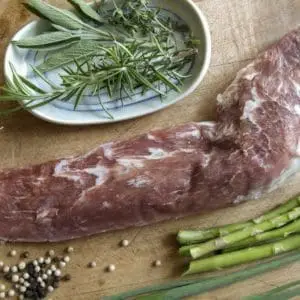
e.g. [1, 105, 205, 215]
[0, 28, 300, 242]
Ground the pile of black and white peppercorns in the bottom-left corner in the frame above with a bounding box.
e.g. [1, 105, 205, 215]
[0, 247, 74, 300]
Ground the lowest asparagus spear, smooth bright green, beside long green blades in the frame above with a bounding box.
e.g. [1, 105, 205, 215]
[183, 235, 300, 275]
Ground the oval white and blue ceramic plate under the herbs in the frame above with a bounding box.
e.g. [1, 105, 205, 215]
[4, 0, 211, 125]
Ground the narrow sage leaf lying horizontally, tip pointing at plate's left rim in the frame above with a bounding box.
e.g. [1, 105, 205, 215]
[12, 31, 80, 49]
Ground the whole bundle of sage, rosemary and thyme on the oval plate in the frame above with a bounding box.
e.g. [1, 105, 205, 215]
[0, 0, 198, 118]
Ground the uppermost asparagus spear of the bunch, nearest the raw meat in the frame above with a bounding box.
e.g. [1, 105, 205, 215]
[177, 196, 300, 245]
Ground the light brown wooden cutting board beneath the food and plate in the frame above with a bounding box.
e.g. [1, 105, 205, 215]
[0, 0, 300, 300]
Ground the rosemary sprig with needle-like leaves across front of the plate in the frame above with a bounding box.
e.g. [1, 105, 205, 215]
[1, 42, 193, 117]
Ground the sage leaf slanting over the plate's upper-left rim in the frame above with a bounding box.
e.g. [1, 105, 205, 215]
[25, 0, 85, 30]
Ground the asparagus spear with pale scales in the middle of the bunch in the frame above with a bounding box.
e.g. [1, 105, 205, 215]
[190, 207, 300, 259]
